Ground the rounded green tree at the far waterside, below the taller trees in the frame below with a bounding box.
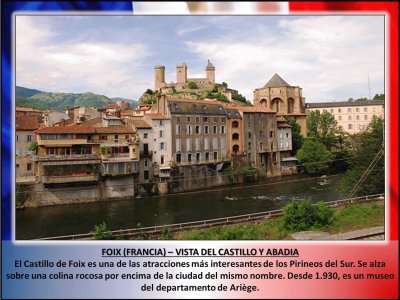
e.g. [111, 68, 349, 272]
[296, 138, 334, 175]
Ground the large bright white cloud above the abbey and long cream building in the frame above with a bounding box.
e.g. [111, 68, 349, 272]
[186, 17, 384, 102]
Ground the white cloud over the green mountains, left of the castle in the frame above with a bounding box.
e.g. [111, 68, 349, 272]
[16, 17, 150, 97]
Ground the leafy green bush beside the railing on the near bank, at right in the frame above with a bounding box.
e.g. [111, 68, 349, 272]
[283, 200, 333, 231]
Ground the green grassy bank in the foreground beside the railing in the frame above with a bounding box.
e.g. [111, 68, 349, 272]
[172, 201, 385, 240]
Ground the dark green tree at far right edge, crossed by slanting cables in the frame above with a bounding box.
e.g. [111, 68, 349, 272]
[339, 117, 385, 196]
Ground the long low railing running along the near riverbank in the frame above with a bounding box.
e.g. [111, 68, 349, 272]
[39, 194, 384, 240]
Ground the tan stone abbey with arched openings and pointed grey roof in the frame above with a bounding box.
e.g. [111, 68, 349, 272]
[254, 73, 307, 136]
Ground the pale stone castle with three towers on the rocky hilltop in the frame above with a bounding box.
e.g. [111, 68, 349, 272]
[154, 61, 215, 94]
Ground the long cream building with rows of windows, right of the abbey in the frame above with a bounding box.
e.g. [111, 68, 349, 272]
[306, 100, 385, 134]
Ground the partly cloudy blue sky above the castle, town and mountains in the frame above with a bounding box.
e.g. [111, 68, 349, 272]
[15, 15, 385, 103]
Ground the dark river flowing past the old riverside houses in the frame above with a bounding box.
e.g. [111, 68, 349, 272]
[16, 175, 343, 240]
